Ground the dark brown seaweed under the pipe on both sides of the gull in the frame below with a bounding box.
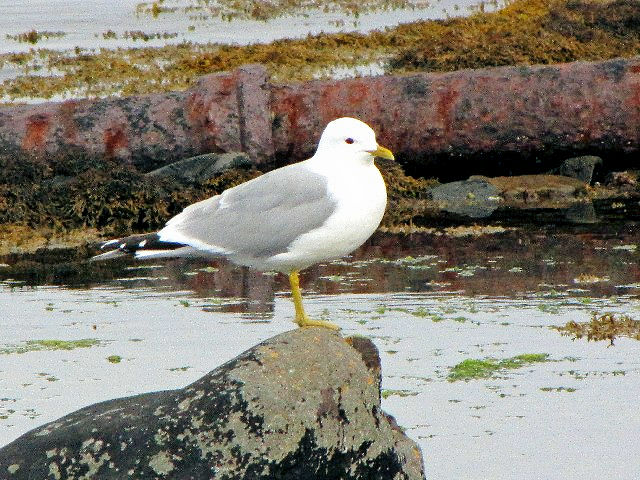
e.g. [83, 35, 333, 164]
[0, 154, 437, 254]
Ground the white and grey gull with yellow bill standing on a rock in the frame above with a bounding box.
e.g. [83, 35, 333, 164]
[92, 117, 394, 330]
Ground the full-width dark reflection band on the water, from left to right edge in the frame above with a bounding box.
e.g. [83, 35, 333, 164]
[0, 230, 640, 314]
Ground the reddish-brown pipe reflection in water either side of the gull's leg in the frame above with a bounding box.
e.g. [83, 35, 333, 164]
[124, 227, 640, 302]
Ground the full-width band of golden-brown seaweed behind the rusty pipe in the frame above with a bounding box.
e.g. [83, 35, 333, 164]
[0, 0, 640, 99]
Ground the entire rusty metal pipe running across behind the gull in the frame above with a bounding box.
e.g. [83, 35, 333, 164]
[0, 58, 640, 170]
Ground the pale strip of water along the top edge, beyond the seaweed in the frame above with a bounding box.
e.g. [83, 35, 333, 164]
[0, 0, 498, 53]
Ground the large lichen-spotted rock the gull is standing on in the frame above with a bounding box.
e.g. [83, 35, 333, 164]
[0, 328, 424, 480]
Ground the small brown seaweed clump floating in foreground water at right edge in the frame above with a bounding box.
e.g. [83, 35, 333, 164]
[553, 312, 640, 346]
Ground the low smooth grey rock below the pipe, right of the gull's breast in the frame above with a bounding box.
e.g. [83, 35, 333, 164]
[430, 178, 500, 218]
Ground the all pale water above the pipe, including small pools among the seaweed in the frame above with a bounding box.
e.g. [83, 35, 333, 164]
[0, 0, 504, 104]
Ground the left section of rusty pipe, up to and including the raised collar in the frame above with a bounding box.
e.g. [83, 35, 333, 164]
[0, 65, 274, 171]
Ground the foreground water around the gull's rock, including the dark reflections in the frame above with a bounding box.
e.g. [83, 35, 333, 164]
[0, 227, 640, 479]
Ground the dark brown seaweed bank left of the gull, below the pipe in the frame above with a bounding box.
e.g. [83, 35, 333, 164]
[0, 152, 260, 244]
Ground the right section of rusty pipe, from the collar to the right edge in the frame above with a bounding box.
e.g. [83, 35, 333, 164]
[271, 57, 640, 174]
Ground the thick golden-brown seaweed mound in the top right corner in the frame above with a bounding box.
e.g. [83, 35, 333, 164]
[389, 0, 640, 71]
